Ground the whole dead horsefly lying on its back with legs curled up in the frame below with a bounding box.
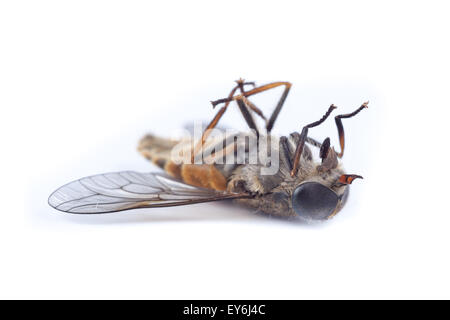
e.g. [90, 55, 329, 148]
[48, 79, 368, 221]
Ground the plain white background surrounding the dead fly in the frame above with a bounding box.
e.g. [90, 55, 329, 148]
[0, 1, 450, 299]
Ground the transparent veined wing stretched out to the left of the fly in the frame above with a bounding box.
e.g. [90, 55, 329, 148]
[48, 171, 248, 213]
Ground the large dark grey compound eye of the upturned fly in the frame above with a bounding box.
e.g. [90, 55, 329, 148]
[292, 182, 338, 220]
